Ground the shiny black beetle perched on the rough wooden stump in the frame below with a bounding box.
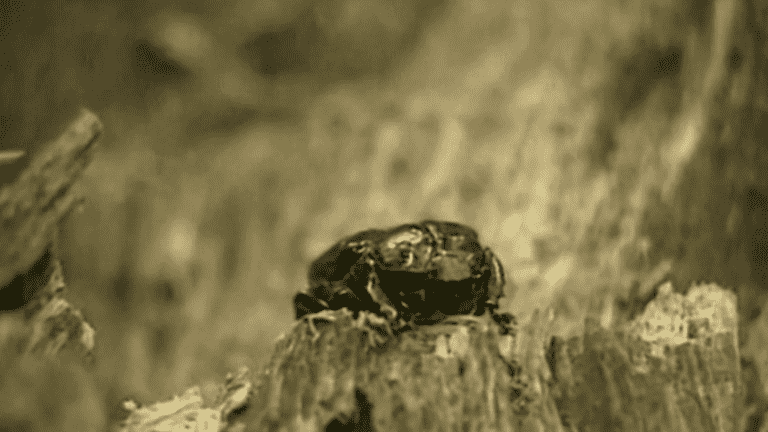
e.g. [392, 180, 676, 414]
[294, 220, 514, 340]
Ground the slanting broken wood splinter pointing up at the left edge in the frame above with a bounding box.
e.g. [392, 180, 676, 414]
[0, 109, 102, 287]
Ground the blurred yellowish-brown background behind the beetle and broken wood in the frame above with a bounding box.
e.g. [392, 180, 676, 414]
[0, 0, 768, 430]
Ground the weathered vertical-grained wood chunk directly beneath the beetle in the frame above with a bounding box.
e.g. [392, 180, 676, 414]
[247, 310, 543, 431]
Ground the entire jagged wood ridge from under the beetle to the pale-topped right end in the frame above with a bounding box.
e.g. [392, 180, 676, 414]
[228, 285, 743, 431]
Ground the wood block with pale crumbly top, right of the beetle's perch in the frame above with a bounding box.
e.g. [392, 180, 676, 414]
[550, 283, 744, 431]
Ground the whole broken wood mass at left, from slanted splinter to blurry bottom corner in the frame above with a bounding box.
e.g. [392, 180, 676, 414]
[0, 110, 107, 431]
